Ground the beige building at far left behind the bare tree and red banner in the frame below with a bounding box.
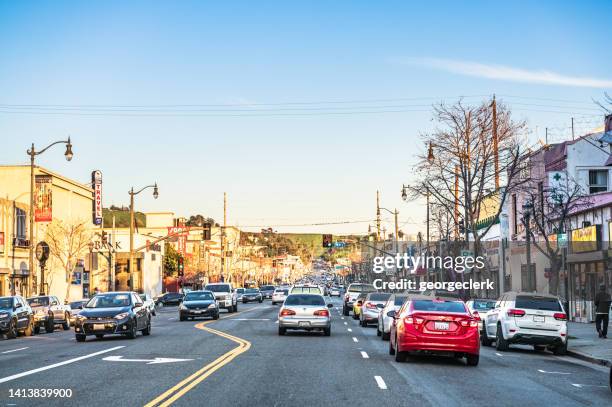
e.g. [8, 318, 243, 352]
[0, 165, 93, 299]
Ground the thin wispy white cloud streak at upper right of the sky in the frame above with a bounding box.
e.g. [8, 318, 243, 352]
[401, 58, 612, 88]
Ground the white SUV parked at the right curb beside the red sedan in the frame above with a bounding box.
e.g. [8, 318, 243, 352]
[480, 292, 567, 355]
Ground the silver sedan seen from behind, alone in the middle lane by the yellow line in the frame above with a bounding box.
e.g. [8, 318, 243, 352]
[278, 294, 333, 336]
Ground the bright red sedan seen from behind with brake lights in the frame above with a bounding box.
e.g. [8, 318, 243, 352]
[389, 296, 480, 366]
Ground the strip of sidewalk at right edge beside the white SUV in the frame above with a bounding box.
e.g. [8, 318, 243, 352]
[567, 322, 612, 366]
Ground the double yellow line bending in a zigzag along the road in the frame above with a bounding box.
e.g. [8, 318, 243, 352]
[145, 307, 258, 407]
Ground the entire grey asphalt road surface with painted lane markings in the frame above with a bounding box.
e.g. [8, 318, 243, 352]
[0, 299, 612, 407]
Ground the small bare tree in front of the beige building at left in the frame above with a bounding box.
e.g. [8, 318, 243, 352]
[46, 219, 91, 298]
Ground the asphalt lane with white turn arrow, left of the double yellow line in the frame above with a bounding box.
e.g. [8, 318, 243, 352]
[0, 304, 256, 405]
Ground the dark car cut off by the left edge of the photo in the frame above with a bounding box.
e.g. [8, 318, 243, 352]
[0, 295, 34, 339]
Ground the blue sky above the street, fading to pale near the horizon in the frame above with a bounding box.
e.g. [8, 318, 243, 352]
[0, 1, 612, 233]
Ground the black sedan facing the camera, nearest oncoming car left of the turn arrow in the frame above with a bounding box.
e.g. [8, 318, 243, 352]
[74, 291, 151, 342]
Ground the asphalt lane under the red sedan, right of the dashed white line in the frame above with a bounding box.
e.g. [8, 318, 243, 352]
[349, 312, 610, 406]
